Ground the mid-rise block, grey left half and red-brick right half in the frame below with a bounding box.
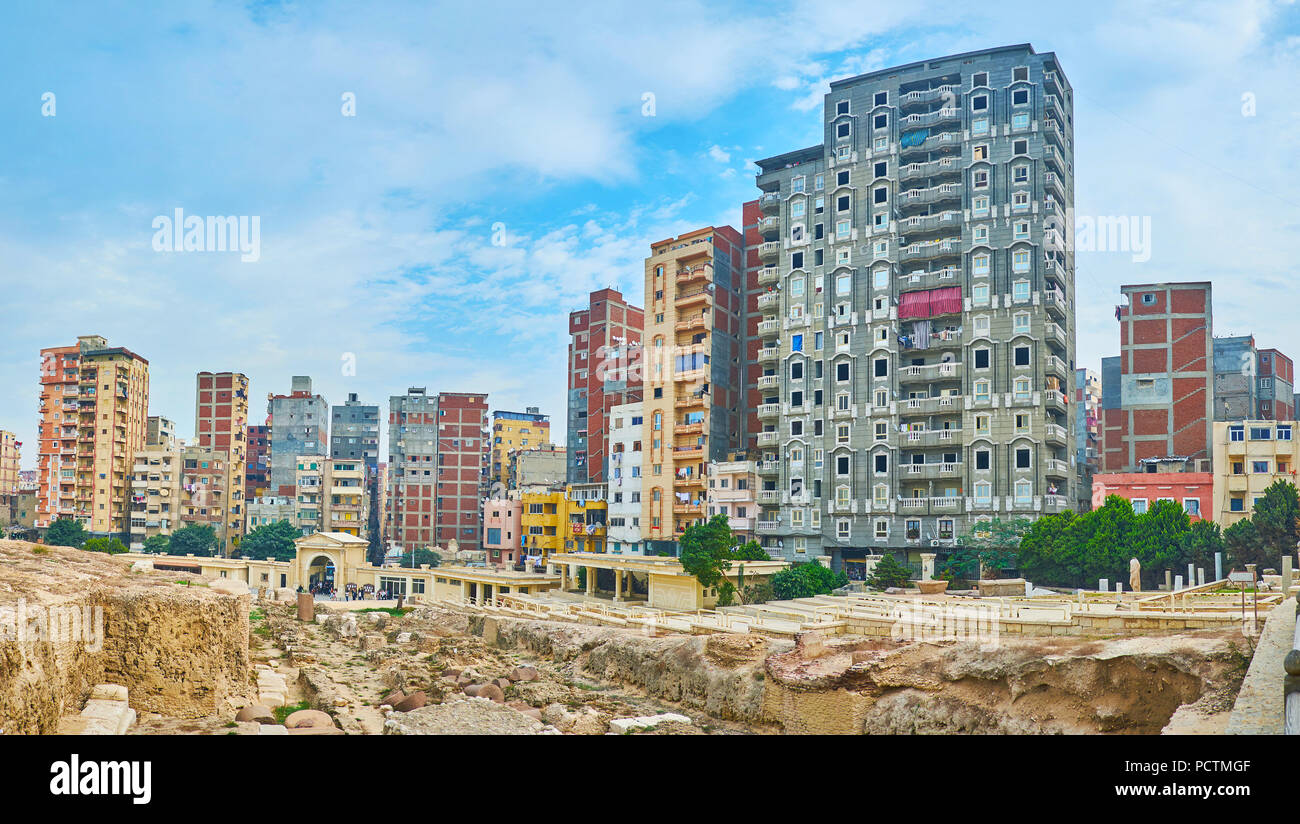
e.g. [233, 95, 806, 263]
[387, 386, 490, 552]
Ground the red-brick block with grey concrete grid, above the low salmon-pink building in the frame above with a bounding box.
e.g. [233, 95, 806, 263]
[1102, 281, 1214, 472]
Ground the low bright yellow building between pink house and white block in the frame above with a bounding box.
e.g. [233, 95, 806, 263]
[520, 483, 610, 558]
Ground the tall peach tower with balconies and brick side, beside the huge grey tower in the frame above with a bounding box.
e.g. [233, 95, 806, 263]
[641, 226, 745, 552]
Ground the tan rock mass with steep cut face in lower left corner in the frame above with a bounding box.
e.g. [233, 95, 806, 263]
[0, 541, 251, 733]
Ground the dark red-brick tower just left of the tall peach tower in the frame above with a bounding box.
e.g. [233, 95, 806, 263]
[566, 289, 645, 483]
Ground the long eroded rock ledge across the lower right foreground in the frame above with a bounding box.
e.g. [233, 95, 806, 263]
[430, 597, 1243, 734]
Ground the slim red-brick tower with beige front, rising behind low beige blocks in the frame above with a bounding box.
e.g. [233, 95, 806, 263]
[194, 372, 248, 535]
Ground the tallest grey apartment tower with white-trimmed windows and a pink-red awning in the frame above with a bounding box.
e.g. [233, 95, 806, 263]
[755, 44, 1075, 573]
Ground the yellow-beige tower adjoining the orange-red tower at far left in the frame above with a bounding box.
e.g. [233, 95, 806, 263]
[74, 335, 150, 535]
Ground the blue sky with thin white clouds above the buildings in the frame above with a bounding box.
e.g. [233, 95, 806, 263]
[0, 0, 1300, 468]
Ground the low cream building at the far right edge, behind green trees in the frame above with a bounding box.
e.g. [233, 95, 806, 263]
[1212, 421, 1300, 528]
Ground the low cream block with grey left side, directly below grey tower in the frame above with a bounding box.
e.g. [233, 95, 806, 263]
[291, 455, 371, 538]
